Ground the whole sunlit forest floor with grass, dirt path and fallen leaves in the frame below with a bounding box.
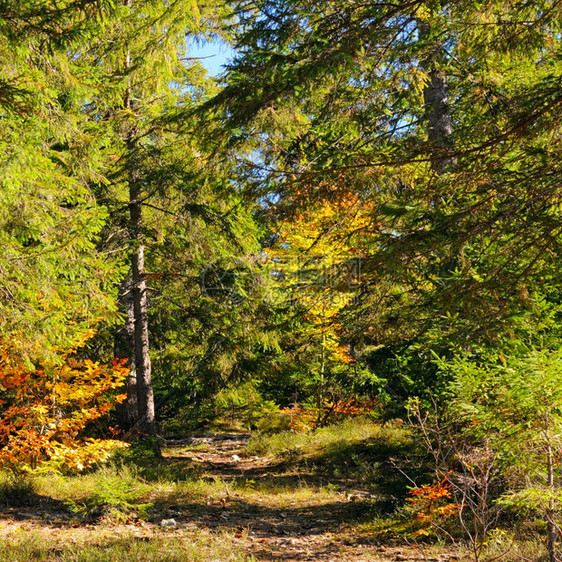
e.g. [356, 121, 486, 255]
[0, 420, 476, 562]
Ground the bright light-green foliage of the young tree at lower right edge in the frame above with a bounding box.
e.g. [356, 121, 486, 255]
[442, 347, 562, 474]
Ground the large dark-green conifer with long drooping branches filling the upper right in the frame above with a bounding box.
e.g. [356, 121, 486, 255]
[214, 0, 562, 394]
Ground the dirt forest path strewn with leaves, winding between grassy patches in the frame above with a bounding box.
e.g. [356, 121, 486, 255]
[162, 435, 458, 562]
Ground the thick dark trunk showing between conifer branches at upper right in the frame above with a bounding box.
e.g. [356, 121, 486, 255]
[418, 20, 454, 174]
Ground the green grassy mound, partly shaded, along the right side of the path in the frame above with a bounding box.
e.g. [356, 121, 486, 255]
[247, 417, 420, 516]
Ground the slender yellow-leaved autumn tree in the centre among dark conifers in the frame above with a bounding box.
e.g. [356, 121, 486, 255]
[270, 193, 374, 425]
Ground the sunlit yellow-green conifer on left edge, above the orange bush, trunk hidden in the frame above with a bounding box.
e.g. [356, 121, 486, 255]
[0, 0, 119, 361]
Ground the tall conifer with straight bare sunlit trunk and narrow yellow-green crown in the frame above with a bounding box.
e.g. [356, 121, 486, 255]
[76, 0, 210, 435]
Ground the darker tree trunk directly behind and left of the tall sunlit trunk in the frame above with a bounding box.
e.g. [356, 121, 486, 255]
[114, 279, 139, 433]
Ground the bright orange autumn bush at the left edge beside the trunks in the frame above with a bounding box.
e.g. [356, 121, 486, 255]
[0, 331, 128, 472]
